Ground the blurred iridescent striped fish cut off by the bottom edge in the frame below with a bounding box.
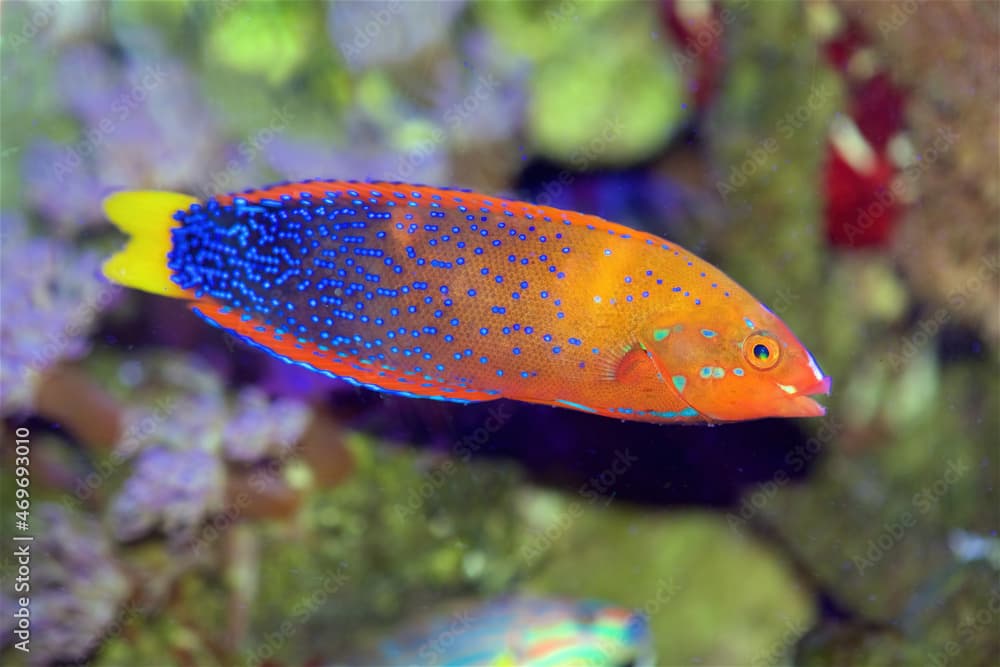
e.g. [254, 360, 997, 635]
[349, 595, 654, 667]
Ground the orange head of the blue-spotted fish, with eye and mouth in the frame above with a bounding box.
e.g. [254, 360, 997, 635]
[642, 294, 831, 422]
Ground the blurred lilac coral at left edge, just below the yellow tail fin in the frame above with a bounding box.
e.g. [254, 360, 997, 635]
[0, 213, 118, 414]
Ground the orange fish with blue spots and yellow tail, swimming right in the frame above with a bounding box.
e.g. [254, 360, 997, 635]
[103, 180, 831, 424]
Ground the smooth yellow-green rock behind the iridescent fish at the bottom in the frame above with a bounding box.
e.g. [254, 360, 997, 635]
[522, 494, 813, 664]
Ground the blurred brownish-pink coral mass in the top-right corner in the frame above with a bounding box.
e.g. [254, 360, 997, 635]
[838, 1, 1000, 345]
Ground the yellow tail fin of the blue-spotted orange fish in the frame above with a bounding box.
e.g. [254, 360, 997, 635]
[102, 190, 198, 297]
